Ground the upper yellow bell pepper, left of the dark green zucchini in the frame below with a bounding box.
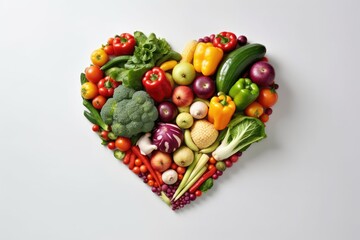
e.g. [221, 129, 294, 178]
[193, 42, 224, 76]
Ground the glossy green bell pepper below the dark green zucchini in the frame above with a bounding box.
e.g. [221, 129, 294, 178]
[229, 78, 259, 111]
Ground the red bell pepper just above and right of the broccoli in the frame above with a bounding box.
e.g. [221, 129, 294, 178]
[142, 67, 172, 102]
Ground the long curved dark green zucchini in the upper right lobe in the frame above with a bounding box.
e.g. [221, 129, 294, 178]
[216, 43, 266, 94]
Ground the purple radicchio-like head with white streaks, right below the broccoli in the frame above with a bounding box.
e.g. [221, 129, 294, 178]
[152, 123, 184, 153]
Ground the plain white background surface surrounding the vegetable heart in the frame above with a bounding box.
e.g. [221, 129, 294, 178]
[0, 0, 360, 240]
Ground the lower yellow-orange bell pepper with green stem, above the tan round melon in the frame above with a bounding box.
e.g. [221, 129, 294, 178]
[208, 93, 236, 130]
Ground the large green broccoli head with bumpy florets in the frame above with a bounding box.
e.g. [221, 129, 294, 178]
[100, 85, 158, 138]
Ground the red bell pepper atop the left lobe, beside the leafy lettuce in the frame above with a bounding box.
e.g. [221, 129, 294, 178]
[112, 33, 136, 56]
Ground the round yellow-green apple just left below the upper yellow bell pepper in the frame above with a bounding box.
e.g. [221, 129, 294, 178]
[172, 62, 196, 85]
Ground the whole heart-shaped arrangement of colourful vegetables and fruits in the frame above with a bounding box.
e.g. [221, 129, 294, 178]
[81, 32, 278, 210]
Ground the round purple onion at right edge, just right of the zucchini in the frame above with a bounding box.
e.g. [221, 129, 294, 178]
[250, 61, 275, 87]
